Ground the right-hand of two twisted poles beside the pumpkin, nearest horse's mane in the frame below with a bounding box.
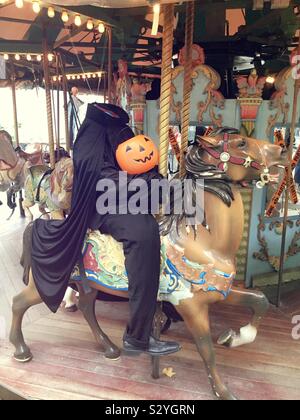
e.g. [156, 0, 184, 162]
[180, 1, 195, 177]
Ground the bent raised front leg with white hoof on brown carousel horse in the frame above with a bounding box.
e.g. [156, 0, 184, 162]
[218, 289, 269, 347]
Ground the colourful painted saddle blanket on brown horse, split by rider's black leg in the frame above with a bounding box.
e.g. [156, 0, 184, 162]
[72, 231, 235, 305]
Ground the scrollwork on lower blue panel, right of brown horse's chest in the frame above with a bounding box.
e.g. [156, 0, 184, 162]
[253, 215, 300, 271]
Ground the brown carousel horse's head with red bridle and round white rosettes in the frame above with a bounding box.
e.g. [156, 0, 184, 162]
[198, 128, 288, 185]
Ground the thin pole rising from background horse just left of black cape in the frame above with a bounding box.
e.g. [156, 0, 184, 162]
[43, 28, 55, 169]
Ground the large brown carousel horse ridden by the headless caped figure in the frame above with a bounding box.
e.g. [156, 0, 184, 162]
[10, 128, 287, 400]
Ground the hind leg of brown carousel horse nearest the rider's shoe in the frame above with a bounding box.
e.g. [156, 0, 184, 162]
[77, 285, 121, 360]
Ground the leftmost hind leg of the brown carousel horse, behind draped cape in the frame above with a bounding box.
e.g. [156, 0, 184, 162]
[9, 273, 42, 363]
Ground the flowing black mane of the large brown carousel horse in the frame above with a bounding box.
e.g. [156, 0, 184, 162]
[159, 127, 239, 235]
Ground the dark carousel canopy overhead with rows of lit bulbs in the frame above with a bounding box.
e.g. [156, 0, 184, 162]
[0, 0, 300, 88]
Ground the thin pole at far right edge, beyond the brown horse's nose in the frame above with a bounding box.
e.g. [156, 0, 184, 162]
[277, 38, 300, 307]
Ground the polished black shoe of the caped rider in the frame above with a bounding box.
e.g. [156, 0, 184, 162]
[123, 337, 181, 356]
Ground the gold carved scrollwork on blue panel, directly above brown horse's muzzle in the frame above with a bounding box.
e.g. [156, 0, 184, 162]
[266, 67, 291, 137]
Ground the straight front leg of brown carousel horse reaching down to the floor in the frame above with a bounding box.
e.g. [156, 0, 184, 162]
[176, 292, 236, 400]
